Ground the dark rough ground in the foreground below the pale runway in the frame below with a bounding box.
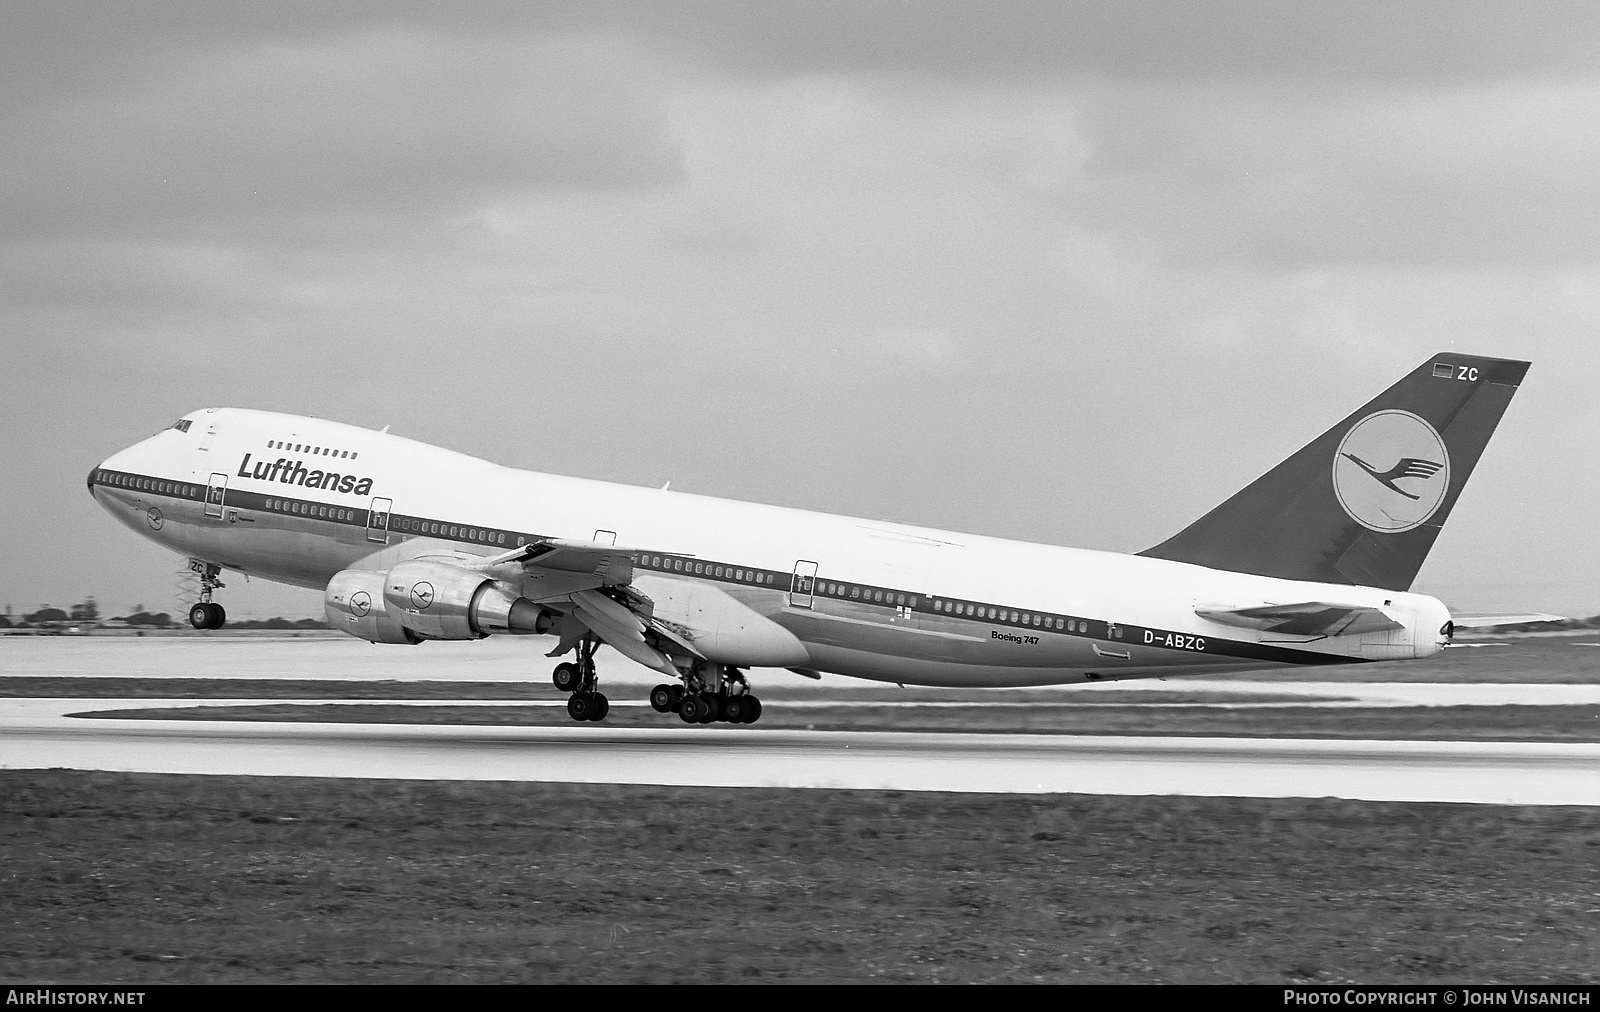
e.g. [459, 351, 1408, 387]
[0, 770, 1600, 983]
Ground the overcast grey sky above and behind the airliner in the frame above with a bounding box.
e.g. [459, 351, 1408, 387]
[0, 0, 1600, 616]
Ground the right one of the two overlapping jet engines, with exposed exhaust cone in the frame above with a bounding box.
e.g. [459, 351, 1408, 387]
[382, 559, 554, 639]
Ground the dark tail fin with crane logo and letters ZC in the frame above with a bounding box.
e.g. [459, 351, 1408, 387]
[1139, 352, 1528, 591]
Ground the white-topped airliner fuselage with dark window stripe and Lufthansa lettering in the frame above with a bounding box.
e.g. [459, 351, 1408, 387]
[90, 408, 1450, 685]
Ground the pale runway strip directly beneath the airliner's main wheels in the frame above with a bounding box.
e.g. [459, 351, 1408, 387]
[0, 698, 1600, 805]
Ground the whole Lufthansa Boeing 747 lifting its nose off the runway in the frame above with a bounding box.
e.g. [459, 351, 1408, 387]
[88, 352, 1528, 724]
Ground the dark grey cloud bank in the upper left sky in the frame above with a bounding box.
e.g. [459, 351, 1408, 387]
[0, 29, 677, 235]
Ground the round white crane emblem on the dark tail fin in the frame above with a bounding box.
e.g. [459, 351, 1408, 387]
[1333, 410, 1450, 535]
